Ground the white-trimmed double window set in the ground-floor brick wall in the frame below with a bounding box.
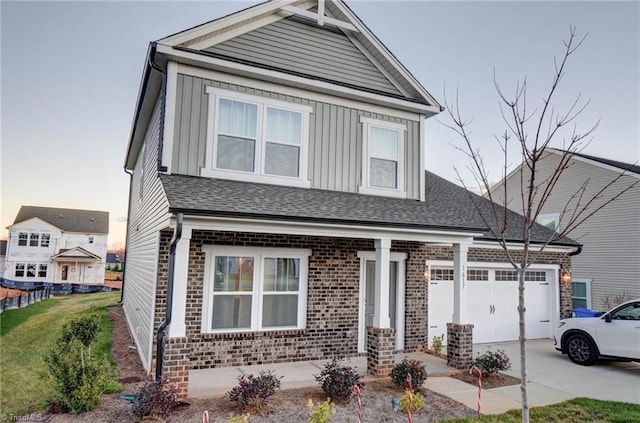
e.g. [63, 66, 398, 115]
[202, 246, 311, 333]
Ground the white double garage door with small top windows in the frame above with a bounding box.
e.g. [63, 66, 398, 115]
[428, 266, 555, 344]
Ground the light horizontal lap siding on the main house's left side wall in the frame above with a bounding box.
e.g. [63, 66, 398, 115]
[123, 100, 169, 370]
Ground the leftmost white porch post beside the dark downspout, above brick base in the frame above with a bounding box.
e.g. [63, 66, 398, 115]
[169, 227, 191, 338]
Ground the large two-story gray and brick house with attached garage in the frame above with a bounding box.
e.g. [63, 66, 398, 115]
[123, 0, 579, 395]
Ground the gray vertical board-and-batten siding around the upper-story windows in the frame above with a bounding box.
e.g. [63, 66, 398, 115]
[171, 74, 423, 199]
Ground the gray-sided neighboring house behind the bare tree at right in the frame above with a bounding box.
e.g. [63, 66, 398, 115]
[492, 148, 640, 310]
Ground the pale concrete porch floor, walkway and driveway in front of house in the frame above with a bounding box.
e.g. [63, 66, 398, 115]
[189, 339, 640, 414]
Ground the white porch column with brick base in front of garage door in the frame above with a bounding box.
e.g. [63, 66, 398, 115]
[447, 243, 473, 369]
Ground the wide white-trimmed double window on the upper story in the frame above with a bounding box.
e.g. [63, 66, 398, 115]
[201, 87, 312, 188]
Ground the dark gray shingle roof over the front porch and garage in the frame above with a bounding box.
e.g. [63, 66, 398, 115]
[160, 172, 579, 245]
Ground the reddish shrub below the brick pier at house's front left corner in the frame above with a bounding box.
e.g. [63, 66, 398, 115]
[132, 377, 178, 419]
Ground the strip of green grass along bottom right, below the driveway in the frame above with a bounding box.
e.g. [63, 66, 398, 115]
[447, 398, 640, 423]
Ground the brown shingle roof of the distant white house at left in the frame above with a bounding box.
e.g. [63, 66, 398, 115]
[13, 206, 109, 234]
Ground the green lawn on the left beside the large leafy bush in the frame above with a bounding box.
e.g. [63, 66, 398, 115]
[0, 292, 120, 416]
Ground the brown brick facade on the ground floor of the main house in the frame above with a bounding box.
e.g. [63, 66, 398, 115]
[153, 230, 571, 396]
